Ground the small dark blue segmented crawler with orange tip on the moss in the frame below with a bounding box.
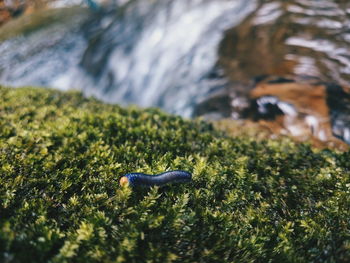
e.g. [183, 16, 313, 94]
[120, 170, 192, 187]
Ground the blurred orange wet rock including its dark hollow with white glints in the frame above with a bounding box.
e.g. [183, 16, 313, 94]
[249, 78, 350, 150]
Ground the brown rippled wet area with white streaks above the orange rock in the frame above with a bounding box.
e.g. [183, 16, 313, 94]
[218, 0, 350, 85]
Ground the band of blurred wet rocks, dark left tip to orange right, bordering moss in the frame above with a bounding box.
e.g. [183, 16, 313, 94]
[195, 76, 350, 150]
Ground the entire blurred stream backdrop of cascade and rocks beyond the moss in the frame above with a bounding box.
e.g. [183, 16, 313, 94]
[0, 0, 350, 148]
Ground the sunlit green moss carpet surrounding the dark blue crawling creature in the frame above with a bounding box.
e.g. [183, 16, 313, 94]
[0, 87, 350, 262]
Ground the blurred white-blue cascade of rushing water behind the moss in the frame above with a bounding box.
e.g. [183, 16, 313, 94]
[0, 0, 254, 116]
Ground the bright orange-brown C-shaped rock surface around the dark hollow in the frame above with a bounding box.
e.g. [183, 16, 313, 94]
[250, 82, 349, 149]
